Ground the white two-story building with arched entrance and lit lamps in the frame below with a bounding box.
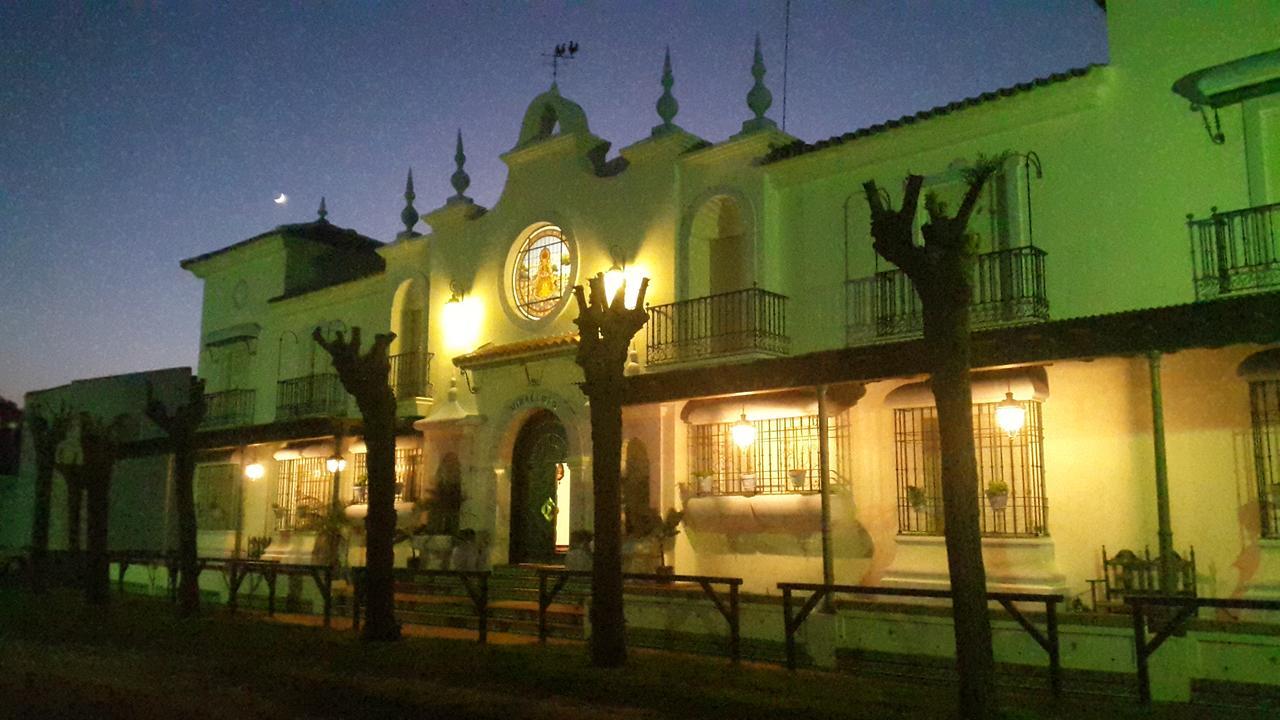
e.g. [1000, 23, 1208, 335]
[165, 3, 1280, 617]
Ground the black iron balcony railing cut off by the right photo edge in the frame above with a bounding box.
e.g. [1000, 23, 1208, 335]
[1187, 202, 1280, 300]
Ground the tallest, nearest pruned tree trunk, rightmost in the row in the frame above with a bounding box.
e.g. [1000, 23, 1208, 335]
[863, 158, 1004, 720]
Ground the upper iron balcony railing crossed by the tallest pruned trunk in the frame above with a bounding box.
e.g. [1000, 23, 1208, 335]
[845, 246, 1048, 345]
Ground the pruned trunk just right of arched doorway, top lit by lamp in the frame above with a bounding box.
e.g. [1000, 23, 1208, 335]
[573, 274, 649, 667]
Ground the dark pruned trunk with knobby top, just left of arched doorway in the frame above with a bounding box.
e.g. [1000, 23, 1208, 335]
[311, 328, 401, 641]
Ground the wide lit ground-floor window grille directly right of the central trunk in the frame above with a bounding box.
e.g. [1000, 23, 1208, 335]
[689, 414, 849, 495]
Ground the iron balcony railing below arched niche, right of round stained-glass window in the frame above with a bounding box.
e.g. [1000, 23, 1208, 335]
[645, 287, 790, 365]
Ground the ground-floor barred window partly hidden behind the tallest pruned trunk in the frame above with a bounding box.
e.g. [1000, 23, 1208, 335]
[893, 400, 1048, 537]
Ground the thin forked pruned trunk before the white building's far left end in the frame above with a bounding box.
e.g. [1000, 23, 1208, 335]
[147, 378, 207, 618]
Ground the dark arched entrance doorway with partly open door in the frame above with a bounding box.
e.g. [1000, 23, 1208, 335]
[508, 410, 570, 562]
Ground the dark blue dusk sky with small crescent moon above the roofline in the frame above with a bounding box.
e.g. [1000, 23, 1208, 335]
[0, 0, 1107, 402]
